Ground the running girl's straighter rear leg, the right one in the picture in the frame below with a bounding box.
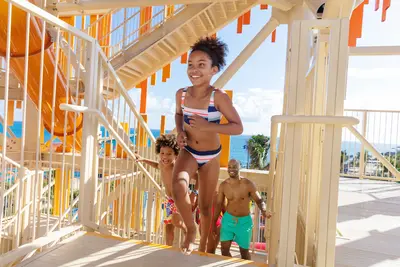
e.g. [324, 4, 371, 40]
[199, 155, 220, 252]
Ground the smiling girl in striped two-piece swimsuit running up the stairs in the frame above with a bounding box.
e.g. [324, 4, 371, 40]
[172, 37, 243, 255]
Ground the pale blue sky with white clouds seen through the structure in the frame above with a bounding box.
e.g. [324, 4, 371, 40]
[130, 1, 400, 137]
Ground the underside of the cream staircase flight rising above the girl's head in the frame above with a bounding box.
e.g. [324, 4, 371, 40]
[111, 0, 259, 89]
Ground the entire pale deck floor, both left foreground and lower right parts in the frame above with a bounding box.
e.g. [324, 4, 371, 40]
[14, 178, 400, 267]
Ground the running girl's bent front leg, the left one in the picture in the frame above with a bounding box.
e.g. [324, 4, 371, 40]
[172, 149, 197, 254]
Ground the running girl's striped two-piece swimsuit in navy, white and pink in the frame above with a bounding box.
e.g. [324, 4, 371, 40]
[181, 87, 222, 168]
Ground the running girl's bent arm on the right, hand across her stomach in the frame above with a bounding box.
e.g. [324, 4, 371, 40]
[190, 91, 243, 135]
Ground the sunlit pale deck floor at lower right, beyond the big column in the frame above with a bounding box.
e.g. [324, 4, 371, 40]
[335, 178, 400, 267]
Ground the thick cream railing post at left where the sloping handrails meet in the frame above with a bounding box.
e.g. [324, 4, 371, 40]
[78, 42, 100, 228]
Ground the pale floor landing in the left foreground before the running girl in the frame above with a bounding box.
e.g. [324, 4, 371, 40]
[18, 233, 267, 267]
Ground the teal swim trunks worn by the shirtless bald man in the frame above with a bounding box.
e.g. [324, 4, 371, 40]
[220, 212, 253, 249]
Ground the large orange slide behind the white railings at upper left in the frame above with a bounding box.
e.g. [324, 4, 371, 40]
[0, 0, 83, 151]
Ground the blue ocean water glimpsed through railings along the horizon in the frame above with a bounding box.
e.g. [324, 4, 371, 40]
[0, 121, 393, 167]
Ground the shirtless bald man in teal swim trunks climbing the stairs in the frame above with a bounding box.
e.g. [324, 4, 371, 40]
[213, 159, 271, 260]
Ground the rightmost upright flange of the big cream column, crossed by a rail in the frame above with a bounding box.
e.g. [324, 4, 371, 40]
[316, 19, 349, 267]
